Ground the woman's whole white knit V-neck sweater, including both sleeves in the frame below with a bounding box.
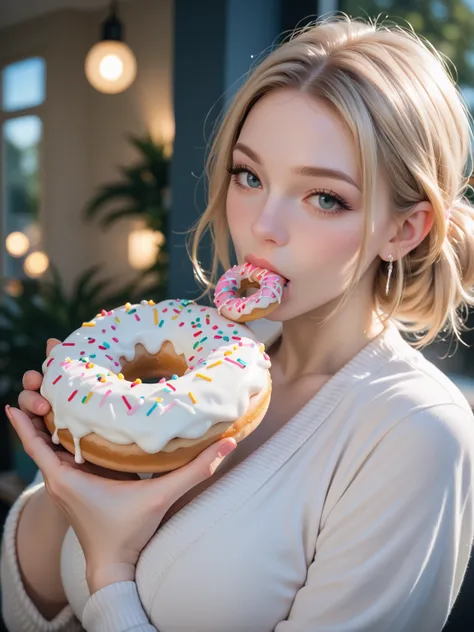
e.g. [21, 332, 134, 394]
[1, 327, 474, 632]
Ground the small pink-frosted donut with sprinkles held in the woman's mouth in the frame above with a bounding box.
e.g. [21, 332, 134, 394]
[214, 263, 286, 323]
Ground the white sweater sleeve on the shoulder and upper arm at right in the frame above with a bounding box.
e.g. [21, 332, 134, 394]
[275, 404, 474, 632]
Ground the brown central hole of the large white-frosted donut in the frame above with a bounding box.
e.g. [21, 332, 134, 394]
[120, 340, 188, 384]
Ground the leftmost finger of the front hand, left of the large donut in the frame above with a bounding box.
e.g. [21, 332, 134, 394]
[5, 406, 61, 478]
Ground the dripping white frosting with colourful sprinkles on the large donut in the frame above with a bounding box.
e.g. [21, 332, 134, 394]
[41, 300, 270, 462]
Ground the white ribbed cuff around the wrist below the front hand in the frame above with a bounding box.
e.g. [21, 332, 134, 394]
[82, 582, 157, 632]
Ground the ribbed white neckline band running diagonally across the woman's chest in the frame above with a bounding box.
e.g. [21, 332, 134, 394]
[137, 324, 410, 586]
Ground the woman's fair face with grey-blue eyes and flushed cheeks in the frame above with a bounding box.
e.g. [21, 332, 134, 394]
[226, 90, 390, 320]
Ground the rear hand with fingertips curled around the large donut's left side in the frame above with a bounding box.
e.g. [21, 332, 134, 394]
[18, 338, 139, 480]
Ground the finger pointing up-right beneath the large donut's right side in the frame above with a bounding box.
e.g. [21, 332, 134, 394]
[158, 439, 237, 502]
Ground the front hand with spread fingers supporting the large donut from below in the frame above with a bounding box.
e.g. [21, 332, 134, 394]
[6, 406, 236, 593]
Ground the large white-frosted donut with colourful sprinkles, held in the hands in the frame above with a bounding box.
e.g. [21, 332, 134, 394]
[41, 300, 271, 473]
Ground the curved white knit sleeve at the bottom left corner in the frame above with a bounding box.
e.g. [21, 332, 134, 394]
[0, 474, 82, 632]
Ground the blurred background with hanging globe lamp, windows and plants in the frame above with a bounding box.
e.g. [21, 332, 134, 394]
[0, 0, 474, 630]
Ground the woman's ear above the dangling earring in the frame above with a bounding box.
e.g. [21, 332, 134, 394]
[380, 202, 434, 260]
